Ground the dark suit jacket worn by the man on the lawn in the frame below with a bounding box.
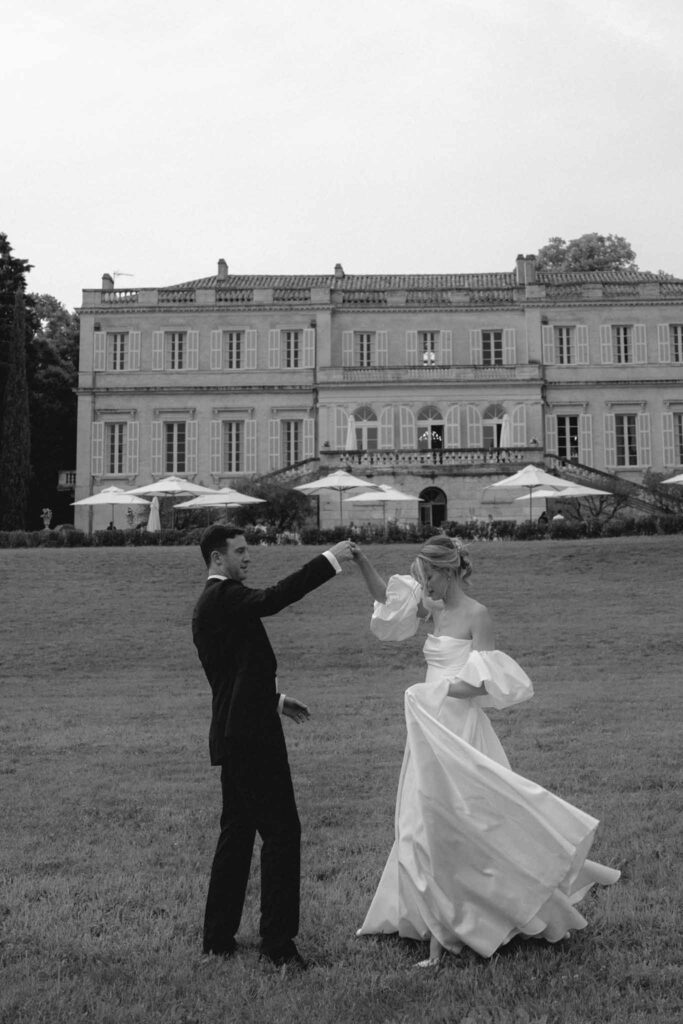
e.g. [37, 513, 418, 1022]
[193, 555, 335, 765]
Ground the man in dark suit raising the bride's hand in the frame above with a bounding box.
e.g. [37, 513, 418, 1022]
[193, 525, 351, 968]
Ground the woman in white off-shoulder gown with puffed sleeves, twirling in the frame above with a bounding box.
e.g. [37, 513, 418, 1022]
[352, 537, 620, 967]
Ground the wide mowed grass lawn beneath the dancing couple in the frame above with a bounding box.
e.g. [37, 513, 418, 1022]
[0, 537, 683, 1024]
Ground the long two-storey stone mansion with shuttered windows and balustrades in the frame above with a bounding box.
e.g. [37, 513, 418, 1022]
[75, 256, 683, 526]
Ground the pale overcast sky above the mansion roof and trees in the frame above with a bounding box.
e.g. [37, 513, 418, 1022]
[5, 0, 683, 308]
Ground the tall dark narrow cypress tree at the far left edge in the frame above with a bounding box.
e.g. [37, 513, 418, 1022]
[0, 288, 31, 529]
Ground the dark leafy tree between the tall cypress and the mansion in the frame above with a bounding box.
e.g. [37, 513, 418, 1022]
[29, 295, 79, 522]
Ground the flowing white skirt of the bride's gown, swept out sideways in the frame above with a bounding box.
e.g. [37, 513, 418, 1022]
[358, 684, 620, 956]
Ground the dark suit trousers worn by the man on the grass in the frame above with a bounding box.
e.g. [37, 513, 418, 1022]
[204, 730, 301, 953]
